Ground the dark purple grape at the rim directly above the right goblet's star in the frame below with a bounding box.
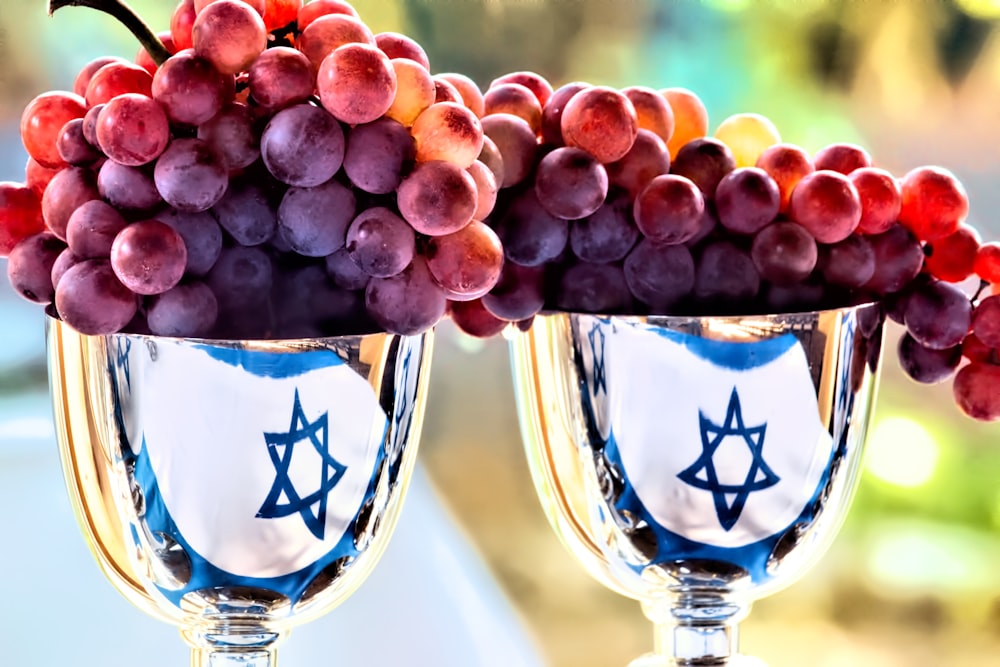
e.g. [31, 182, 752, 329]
[694, 241, 760, 309]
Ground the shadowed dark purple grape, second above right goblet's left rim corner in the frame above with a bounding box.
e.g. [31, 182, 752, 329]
[495, 188, 569, 266]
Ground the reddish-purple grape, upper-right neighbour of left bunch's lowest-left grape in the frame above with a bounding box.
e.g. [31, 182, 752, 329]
[111, 220, 187, 295]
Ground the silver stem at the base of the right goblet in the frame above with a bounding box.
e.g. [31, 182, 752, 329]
[629, 590, 750, 667]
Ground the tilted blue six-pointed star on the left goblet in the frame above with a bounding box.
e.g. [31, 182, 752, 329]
[257, 389, 347, 540]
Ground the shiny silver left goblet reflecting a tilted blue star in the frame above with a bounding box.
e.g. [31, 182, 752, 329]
[47, 318, 433, 667]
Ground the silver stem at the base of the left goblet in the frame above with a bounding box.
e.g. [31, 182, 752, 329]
[181, 621, 284, 667]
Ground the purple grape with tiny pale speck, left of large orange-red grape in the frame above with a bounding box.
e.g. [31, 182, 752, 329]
[345, 206, 416, 278]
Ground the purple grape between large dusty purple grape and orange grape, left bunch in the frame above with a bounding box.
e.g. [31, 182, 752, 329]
[344, 118, 416, 194]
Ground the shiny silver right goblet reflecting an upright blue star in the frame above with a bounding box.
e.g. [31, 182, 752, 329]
[511, 304, 883, 667]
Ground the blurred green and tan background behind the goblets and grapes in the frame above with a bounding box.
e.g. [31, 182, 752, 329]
[0, 0, 1000, 667]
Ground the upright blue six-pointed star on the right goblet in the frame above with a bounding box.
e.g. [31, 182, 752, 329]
[677, 387, 781, 530]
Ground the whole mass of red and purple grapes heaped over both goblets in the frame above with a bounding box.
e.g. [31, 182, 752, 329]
[0, 0, 1000, 420]
